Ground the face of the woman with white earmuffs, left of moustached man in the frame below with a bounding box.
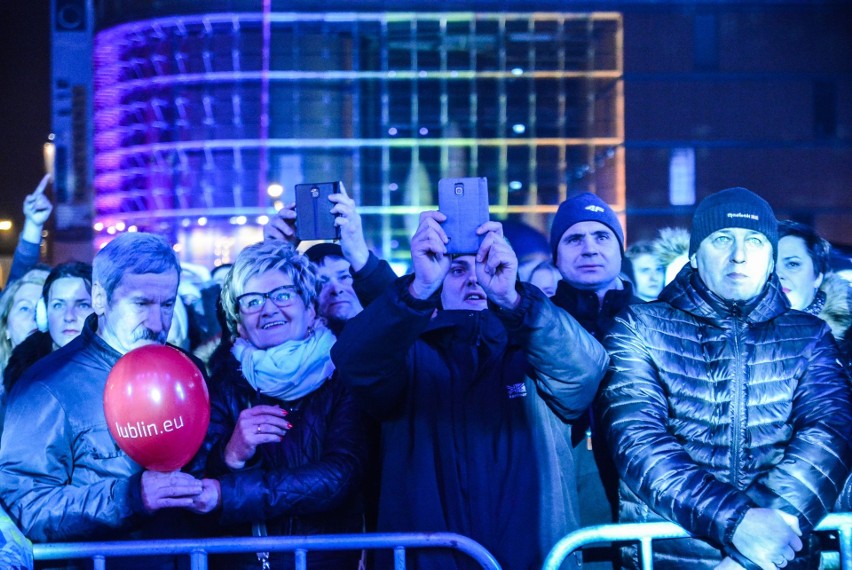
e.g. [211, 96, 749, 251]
[47, 277, 93, 347]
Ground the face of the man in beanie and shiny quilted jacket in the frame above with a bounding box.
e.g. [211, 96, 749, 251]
[690, 228, 773, 301]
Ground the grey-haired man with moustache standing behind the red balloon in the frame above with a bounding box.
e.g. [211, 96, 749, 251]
[0, 233, 209, 560]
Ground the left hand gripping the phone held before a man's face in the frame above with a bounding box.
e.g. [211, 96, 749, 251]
[409, 210, 450, 299]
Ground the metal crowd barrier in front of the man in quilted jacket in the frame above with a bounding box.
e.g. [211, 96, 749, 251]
[542, 513, 852, 570]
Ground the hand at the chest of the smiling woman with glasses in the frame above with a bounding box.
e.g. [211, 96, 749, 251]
[225, 406, 293, 469]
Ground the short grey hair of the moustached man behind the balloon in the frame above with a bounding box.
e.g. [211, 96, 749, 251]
[92, 232, 180, 303]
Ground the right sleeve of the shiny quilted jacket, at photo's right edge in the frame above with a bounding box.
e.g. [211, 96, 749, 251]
[748, 327, 852, 532]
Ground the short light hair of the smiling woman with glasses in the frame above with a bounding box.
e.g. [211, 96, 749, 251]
[221, 241, 317, 336]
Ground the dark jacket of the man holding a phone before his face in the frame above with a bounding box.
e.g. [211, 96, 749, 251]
[332, 277, 607, 570]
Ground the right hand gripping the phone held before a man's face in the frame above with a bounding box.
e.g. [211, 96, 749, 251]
[476, 222, 520, 308]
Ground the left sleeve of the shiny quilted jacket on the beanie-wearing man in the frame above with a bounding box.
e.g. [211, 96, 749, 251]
[597, 308, 757, 546]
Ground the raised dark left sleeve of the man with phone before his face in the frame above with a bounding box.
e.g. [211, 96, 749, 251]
[331, 276, 437, 417]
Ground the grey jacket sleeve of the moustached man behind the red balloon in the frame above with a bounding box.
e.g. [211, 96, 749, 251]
[0, 382, 142, 542]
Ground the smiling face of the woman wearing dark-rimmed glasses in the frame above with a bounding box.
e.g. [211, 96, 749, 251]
[237, 269, 316, 349]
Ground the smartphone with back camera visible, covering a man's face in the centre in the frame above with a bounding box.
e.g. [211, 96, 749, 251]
[438, 178, 488, 255]
